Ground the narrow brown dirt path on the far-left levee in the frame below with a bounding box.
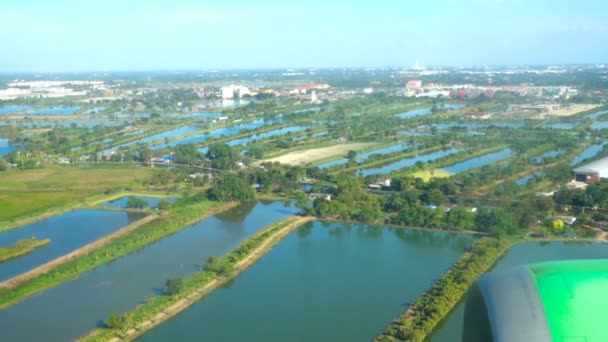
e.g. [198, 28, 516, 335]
[0, 214, 160, 288]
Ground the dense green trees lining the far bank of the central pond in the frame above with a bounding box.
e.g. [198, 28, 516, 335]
[298, 171, 555, 236]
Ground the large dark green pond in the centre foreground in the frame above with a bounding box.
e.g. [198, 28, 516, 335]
[141, 222, 473, 342]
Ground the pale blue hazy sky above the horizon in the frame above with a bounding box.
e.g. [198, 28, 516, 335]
[0, 0, 608, 72]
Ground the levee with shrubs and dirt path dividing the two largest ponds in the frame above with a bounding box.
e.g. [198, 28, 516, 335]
[77, 216, 314, 342]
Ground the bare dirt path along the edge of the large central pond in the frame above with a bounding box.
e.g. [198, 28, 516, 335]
[108, 217, 314, 342]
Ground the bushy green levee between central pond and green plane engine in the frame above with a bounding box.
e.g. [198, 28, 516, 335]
[375, 238, 512, 342]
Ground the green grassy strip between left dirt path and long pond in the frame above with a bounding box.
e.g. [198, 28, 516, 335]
[0, 201, 237, 309]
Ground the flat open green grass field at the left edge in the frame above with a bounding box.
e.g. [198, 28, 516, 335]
[0, 167, 155, 226]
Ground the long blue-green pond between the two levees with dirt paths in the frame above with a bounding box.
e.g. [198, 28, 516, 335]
[0, 202, 296, 341]
